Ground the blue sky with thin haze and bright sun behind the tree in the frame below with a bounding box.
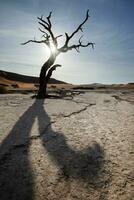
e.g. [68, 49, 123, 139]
[0, 0, 134, 84]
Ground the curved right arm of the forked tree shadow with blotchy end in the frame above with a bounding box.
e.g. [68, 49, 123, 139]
[38, 104, 105, 188]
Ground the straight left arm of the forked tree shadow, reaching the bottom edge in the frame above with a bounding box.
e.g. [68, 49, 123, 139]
[0, 102, 36, 200]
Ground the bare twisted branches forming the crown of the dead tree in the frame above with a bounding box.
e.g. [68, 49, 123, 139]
[22, 10, 95, 55]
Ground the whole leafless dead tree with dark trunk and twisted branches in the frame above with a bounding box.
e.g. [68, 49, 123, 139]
[22, 10, 94, 99]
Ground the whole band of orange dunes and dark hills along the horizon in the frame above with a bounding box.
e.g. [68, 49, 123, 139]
[0, 70, 134, 90]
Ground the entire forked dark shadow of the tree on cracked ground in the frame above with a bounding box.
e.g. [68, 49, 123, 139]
[0, 99, 104, 200]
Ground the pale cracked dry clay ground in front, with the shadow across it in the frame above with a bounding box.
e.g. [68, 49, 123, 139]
[0, 91, 134, 200]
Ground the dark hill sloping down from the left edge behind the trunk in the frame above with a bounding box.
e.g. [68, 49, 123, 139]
[0, 70, 66, 84]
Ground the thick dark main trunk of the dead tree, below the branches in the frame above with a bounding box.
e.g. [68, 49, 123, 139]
[37, 54, 56, 99]
